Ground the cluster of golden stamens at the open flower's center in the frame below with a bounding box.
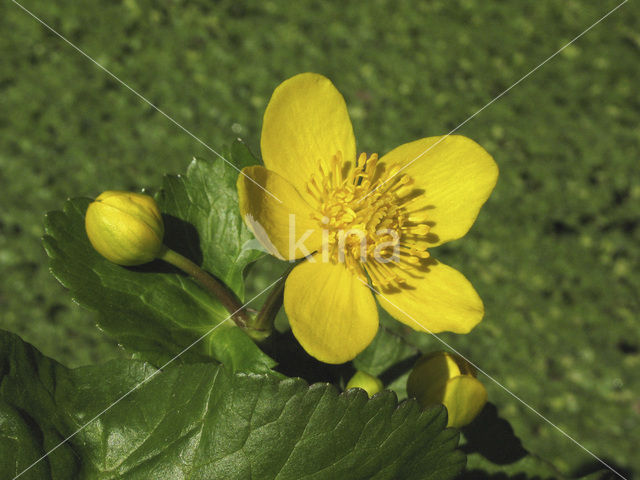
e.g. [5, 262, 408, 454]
[307, 152, 429, 289]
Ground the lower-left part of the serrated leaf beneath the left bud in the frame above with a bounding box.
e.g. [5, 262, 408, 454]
[43, 195, 215, 356]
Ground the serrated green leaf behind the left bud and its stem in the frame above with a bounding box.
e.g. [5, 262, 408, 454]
[43, 144, 275, 372]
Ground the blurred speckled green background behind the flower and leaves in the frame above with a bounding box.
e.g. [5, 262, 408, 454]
[0, 0, 640, 478]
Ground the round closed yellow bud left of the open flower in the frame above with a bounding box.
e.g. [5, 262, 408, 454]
[85, 191, 164, 266]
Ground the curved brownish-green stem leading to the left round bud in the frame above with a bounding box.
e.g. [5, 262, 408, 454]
[158, 247, 251, 328]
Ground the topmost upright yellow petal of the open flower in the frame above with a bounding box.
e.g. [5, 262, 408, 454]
[260, 73, 356, 202]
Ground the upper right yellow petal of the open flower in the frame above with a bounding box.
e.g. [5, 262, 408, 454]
[381, 135, 498, 246]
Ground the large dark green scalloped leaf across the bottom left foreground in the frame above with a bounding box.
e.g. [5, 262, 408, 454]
[0, 332, 464, 480]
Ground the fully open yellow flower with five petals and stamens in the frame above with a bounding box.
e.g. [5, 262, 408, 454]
[238, 73, 498, 363]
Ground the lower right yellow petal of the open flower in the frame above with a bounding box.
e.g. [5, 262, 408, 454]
[378, 259, 484, 333]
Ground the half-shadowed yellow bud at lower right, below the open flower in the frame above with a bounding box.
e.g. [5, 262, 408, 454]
[407, 352, 487, 428]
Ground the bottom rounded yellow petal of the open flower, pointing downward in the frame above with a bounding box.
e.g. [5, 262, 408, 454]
[284, 257, 378, 363]
